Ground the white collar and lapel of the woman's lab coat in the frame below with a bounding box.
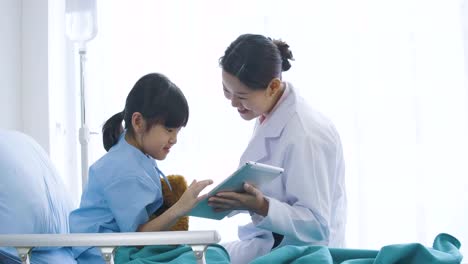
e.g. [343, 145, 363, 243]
[241, 83, 297, 164]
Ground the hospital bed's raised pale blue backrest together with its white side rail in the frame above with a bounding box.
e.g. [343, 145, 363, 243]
[0, 129, 220, 264]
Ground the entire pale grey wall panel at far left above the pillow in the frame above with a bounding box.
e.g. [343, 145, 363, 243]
[0, 0, 50, 152]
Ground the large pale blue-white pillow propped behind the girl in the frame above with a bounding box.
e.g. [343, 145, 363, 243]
[0, 129, 72, 263]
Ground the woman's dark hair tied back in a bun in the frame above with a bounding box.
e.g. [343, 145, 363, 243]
[219, 34, 294, 90]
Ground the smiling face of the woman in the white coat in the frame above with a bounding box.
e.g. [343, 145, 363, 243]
[222, 71, 271, 120]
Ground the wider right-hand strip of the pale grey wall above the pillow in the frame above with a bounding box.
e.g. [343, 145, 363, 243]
[21, 0, 50, 152]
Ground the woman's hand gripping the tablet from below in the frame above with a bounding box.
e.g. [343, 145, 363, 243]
[208, 183, 269, 216]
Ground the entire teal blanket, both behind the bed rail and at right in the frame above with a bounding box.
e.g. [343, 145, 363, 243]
[115, 234, 463, 264]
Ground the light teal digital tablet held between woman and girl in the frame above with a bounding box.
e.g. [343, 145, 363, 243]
[188, 161, 283, 220]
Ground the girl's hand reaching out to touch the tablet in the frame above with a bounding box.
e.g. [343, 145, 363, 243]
[173, 180, 213, 217]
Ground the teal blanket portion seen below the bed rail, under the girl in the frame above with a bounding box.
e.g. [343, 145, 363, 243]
[114, 245, 230, 264]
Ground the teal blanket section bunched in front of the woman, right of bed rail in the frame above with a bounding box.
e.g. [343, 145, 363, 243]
[251, 234, 463, 264]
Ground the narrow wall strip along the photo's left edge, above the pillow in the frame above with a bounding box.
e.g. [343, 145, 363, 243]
[0, 0, 22, 130]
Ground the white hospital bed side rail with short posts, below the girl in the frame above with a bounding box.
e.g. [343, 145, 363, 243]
[0, 231, 221, 264]
